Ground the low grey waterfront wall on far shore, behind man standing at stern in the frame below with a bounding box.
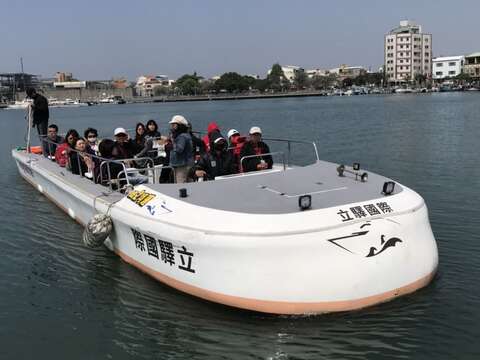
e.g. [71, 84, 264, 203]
[16, 88, 134, 101]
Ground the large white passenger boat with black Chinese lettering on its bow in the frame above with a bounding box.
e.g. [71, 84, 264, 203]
[12, 136, 438, 314]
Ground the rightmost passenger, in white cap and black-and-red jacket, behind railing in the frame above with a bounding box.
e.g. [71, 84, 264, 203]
[240, 126, 273, 172]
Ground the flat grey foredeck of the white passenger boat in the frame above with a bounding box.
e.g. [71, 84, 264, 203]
[147, 161, 402, 214]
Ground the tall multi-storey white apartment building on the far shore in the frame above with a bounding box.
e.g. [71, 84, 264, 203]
[384, 20, 432, 84]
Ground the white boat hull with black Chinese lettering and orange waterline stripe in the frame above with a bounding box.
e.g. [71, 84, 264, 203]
[13, 152, 438, 314]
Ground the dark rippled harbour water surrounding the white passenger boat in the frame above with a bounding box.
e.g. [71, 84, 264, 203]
[0, 93, 480, 359]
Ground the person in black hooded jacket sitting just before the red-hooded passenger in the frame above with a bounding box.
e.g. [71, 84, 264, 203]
[193, 136, 237, 180]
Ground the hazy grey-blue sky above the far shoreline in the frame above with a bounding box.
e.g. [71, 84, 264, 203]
[0, 0, 480, 81]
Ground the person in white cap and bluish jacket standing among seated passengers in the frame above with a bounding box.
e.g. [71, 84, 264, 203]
[169, 115, 194, 183]
